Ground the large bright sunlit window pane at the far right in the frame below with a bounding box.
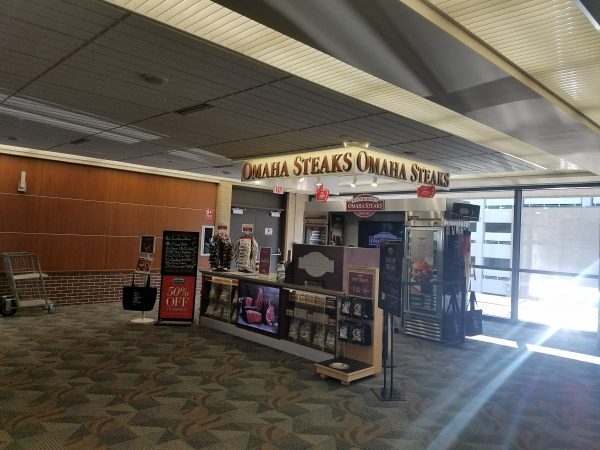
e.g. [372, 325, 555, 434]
[518, 189, 600, 331]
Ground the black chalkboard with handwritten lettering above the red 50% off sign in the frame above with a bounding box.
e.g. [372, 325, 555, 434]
[161, 231, 200, 276]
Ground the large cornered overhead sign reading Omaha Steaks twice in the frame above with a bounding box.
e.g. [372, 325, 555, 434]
[242, 147, 450, 187]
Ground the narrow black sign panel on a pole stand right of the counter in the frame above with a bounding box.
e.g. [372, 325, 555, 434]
[377, 241, 404, 316]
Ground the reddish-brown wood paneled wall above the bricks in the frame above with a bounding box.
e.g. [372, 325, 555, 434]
[0, 155, 217, 272]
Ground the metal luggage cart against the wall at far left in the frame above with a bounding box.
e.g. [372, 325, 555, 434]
[0, 252, 55, 316]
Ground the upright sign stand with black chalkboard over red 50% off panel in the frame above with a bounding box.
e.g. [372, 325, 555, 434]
[157, 231, 200, 325]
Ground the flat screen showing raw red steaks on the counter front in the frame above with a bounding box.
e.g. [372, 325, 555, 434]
[236, 281, 281, 337]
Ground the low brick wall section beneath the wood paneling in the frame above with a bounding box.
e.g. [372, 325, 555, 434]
[0, 271, 201, 307]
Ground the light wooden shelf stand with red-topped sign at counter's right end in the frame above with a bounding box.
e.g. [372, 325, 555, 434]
[315, 267, 383, 386]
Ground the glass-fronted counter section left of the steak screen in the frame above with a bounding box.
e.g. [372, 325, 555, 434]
[200, 275, 239, 323]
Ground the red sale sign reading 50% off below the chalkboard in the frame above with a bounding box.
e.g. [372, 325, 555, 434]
[158, 275, 196, 321]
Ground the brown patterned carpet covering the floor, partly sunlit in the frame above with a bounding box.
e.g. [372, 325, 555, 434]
[0, 303, 600, 450]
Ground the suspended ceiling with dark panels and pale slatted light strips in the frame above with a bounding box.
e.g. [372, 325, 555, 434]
[0, 0, 600, 190]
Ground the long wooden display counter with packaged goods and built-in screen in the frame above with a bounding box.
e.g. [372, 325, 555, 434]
[200, 260, 383, 386]
